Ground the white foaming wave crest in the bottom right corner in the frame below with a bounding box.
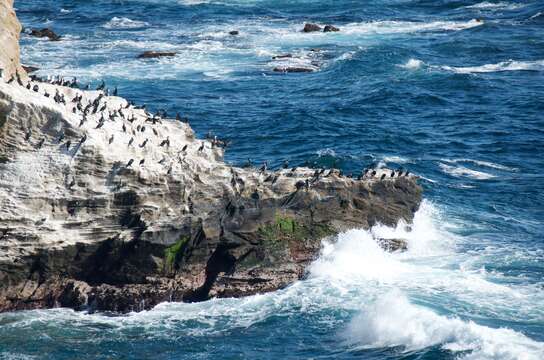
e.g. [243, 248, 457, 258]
[346, 290, 544, 360]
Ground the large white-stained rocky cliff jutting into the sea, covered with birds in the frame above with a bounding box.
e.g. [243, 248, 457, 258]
[0, 0, 421, 312]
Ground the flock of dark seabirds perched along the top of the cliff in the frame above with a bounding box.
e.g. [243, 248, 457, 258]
[0, 72, 410, 190]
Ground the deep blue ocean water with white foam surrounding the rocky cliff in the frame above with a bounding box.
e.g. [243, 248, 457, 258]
[0, 0, 544, 359]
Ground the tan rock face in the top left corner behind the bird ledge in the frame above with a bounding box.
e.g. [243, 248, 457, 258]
[0, 0, 26, 81]
